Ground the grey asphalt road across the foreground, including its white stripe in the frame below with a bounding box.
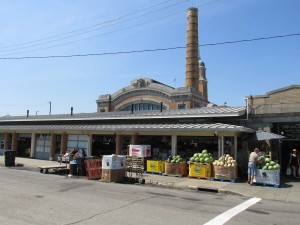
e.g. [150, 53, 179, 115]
[0, 167, 300, 225]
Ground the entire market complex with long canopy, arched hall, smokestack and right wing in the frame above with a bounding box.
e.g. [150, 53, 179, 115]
[0, 8, 300, 178]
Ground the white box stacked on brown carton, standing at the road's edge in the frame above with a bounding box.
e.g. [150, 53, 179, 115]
[101, 155, 126, 182]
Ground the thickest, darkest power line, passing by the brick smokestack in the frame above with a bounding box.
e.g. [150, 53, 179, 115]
[0, 33, 300, 60]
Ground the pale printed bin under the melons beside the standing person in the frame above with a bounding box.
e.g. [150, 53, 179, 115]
[254, 169, 280, 188]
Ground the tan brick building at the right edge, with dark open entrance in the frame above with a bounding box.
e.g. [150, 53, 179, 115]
[242, 85, 300, 174]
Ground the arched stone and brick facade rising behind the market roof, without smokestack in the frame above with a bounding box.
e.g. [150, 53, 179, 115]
[96, 78, 208, 112]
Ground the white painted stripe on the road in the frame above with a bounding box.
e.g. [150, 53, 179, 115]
[204, 198, 261, 225]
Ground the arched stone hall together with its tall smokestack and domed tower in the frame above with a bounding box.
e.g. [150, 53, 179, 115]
[96, 8, 209, 112]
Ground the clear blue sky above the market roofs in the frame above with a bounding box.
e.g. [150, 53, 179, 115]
[0, 0, 300, 116]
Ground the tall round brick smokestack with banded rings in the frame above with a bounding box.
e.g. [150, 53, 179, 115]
[185, 8, 199, 90]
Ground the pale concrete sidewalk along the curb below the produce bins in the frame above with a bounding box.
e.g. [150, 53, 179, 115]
[0, 155, 300, 203]
